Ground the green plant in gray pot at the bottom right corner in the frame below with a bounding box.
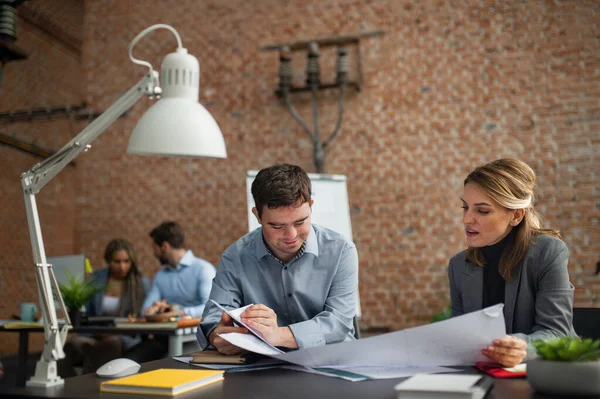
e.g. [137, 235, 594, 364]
[527, 337, 600, 396]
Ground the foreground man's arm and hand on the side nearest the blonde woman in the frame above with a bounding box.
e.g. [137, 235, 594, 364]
[244, 244, 358, 349]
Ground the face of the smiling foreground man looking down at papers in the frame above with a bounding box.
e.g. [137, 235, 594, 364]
[252, 200, 314, 262]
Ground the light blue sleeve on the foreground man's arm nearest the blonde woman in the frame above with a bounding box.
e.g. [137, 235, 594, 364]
[289, 244, 358, 349]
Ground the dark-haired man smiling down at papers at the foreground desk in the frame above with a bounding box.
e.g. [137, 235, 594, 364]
[197, 164, 358, 355]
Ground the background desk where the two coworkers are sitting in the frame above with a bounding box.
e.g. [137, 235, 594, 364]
[0, 325, 198, 387]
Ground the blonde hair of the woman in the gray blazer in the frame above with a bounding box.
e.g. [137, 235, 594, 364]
[464, 158, 560, 280]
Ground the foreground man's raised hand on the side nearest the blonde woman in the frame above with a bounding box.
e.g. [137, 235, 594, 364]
[241, 304, 298, 349]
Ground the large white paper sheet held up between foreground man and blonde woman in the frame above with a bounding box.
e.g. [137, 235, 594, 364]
[221, 304, 506, 368]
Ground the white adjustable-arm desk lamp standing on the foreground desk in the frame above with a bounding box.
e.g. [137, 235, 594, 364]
[21, 24, 227, 388]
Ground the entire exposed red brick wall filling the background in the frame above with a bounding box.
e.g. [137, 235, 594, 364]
[0, 0, 600, 352]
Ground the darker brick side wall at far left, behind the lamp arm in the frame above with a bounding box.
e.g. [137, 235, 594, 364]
[0, 0, 83, 356]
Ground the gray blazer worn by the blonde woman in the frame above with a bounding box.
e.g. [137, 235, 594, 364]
[448, 234, 576, 343]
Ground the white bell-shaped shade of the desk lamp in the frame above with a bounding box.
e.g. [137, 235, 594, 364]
[127, 48, 227, 158]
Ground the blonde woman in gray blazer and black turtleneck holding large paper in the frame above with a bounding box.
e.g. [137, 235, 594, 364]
[448, 158, 575, 367]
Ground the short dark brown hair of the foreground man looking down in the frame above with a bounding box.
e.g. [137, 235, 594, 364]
[252, 164, 311, 218]
